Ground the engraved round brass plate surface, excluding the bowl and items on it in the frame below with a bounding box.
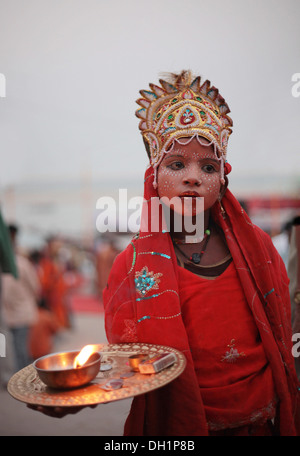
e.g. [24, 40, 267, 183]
[7, 343, 186, 407]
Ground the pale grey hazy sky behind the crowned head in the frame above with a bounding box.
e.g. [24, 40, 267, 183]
[0, 0, 300, 187]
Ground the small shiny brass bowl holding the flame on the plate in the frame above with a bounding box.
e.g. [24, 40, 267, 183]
[33, 351, 101, 389]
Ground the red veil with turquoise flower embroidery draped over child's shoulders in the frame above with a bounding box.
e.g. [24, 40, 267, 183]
[103, 167, 299, 436]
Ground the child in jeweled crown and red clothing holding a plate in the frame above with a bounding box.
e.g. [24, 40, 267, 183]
[103, 71, 299, 436]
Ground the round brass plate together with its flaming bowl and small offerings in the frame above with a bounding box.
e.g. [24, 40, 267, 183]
[7, 343, 186, 407]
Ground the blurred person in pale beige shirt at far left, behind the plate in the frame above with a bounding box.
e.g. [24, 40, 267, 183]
[2, 225, 40, 370]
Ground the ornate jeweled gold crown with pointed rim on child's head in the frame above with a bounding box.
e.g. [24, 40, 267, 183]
[136, 71, 233, 172]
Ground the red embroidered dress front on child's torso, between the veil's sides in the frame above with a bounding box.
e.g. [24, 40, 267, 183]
[179, 262, 277, 431]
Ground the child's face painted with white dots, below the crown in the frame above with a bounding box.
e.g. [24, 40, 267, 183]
[157, 138, 221, 215]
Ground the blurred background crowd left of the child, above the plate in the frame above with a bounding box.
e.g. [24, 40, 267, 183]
[0, 216, 119, 386]
